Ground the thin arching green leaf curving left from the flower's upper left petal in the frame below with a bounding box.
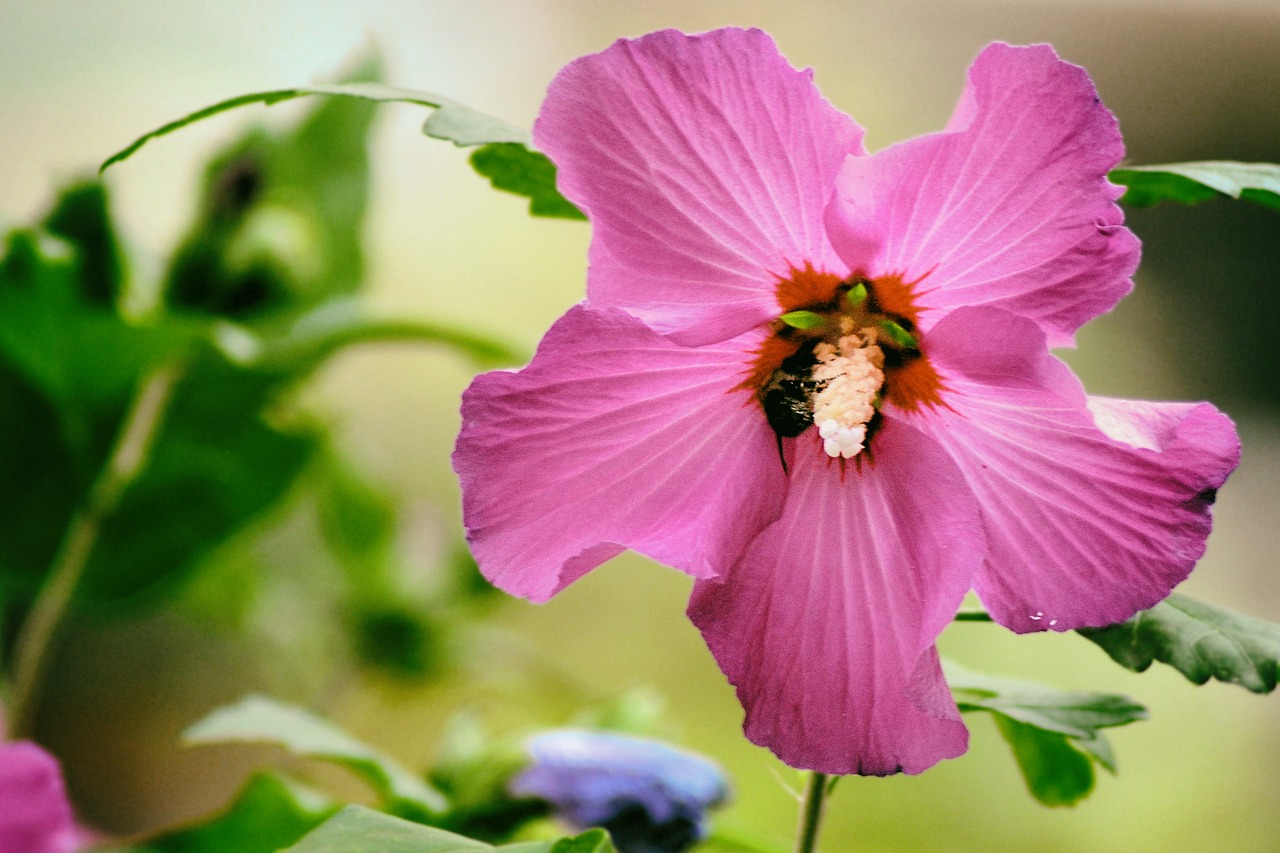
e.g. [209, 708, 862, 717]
[100, 83, 529, 172]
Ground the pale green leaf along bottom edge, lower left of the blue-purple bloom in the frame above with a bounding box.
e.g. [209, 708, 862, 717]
[284, 806, 617, 853]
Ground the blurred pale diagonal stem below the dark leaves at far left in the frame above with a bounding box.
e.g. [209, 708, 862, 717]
[9, 364, 182, 739]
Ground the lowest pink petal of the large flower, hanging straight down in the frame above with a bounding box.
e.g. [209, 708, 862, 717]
[689, 421, 983, 775]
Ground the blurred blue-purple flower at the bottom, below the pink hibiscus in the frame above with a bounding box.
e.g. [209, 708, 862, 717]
[511, 729, 728, 853]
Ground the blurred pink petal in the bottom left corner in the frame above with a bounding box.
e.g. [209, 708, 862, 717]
[0, 740, 79, 853]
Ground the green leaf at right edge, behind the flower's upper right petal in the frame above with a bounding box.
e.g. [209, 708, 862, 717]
[1108, 160, 1280, 210]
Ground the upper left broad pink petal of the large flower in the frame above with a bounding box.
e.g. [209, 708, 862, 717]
[534, 29, 863, 343]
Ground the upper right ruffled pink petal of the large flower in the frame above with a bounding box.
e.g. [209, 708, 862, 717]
[828, 44, 1139, 346]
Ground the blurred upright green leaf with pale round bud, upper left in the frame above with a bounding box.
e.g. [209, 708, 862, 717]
[164, 56, 380, 319]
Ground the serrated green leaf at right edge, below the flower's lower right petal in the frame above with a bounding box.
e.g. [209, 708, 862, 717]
[1078, 593, 1280, 693]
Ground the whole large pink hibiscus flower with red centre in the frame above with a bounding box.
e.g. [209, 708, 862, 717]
[454, 29, 1239, 775]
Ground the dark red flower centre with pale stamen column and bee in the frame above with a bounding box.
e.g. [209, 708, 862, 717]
[740, 265, 941, 460]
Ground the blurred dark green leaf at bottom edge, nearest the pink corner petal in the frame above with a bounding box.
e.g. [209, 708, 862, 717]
[138, 774, 338, 853]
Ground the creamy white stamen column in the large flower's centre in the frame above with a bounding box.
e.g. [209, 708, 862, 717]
[813, 318, 884, 459]
